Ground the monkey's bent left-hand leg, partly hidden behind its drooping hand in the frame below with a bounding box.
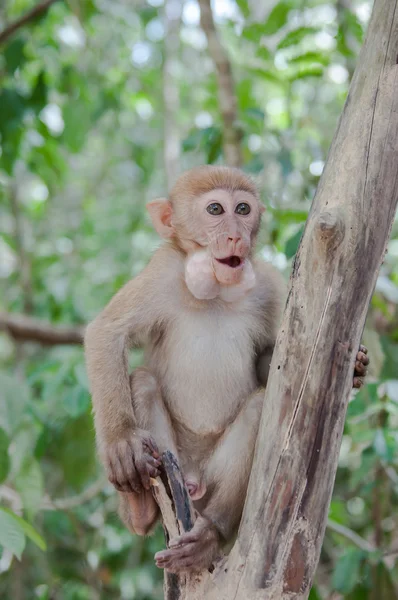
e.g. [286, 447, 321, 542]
[119, 368, 177, 535]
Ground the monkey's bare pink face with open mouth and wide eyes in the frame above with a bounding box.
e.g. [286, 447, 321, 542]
[193, 189, 261, 285]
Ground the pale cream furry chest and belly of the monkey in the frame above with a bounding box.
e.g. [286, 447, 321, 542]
[151, 313, 256, 435]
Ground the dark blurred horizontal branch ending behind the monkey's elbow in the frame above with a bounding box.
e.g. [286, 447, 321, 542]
[0, 312, 84, 346]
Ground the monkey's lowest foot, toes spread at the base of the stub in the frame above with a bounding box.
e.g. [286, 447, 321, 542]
[155, 517, 220, 573]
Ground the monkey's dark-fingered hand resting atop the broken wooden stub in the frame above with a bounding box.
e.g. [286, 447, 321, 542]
[104, 429, 161, 494]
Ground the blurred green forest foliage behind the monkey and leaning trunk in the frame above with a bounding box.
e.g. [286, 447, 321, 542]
[0, 0, 398, 600]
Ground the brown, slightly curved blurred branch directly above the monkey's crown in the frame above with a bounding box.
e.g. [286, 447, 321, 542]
[199, 0, 242, 167]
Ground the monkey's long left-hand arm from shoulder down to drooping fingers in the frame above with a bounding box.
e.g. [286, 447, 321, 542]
[85, 248, 176, 491]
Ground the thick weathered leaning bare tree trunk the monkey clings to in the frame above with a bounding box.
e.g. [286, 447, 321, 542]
[154, 0, 398, 600]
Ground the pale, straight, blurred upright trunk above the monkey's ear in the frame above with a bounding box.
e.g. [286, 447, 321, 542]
[163, 0, 182, 190]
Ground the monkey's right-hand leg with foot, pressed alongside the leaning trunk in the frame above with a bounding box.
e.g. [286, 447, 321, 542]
[155, 388, 264, 573]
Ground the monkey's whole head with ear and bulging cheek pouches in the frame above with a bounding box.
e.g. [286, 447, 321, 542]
[148, 165, 264, 298]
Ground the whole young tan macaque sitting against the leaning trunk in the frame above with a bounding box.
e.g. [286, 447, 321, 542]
[85, 166, 368, 573]
